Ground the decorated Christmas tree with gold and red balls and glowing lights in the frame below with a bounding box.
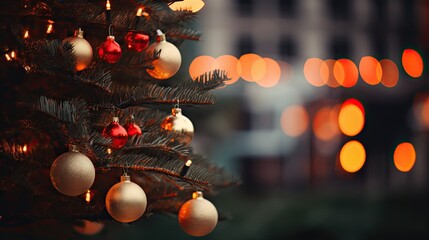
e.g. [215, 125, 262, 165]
[0, 0, 237, 236]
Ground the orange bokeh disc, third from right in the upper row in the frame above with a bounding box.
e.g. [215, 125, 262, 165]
[359, 56, 383, 85]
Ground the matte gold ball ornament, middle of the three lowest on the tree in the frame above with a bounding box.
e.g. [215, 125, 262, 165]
[106, 175, 147, 223]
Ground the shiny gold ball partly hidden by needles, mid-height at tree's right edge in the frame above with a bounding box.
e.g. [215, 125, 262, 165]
[161, 107, 194, 145]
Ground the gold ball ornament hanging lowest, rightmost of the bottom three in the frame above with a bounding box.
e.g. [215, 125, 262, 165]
[179, 191, 218, 237]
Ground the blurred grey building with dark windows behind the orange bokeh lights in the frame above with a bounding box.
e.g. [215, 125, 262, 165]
[196, 0, 429, 192]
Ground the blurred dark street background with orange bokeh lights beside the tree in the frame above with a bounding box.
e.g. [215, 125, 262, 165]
[69, 0, 429, 240]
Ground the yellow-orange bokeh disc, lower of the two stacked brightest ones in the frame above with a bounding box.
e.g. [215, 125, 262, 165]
[340, 140, 366, 173]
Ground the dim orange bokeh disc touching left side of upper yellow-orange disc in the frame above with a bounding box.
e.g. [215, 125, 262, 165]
[313, 107, 340, 141]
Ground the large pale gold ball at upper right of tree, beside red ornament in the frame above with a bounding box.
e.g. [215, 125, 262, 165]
[146, 30, 182, 80]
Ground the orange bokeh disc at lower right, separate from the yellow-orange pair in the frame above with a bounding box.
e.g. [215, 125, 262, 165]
[393, 142, 416, 172]
